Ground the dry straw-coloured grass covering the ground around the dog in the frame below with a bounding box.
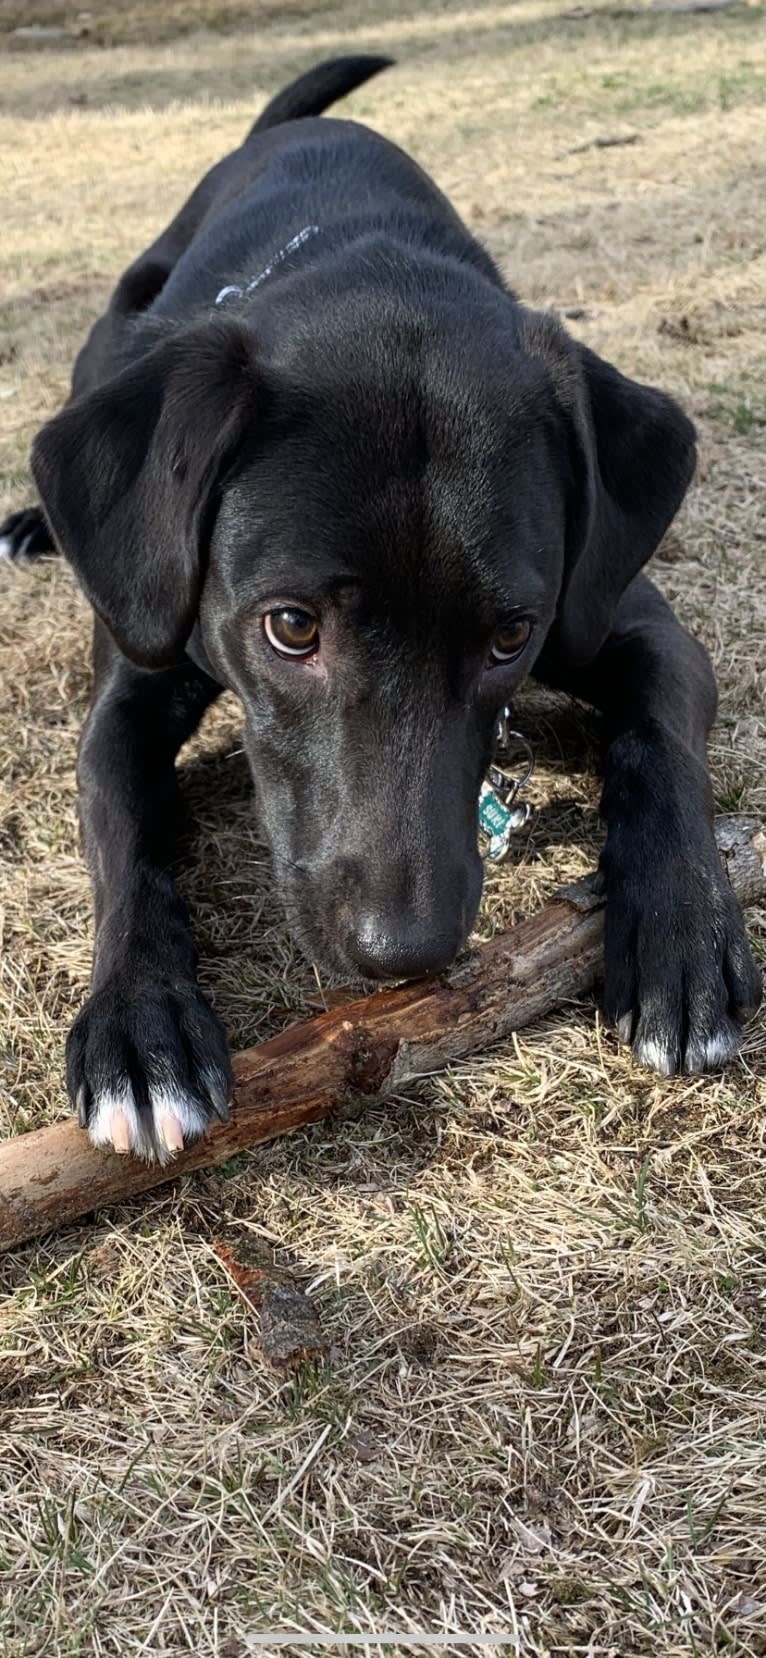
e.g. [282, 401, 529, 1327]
[0, 0, 766, 1658]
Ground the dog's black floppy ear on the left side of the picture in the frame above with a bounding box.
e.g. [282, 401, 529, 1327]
[32, 322, 255, 668]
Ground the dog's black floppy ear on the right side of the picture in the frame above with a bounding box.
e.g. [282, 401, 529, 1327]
[527, 318, 696, 667]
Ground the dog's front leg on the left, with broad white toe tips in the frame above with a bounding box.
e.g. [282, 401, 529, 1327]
[66, 628, 232, 1161]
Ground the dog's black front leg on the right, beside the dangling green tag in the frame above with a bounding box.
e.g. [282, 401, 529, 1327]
[537, 575, 761, 1076]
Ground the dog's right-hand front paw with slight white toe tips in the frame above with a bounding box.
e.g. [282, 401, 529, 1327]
[604, 847, 763, 1076]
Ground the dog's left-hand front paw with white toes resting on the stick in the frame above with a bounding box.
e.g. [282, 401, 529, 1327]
[66, 978, 234, 1162]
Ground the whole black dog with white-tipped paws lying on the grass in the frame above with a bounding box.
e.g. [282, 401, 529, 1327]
[3, 58, 761, 1157]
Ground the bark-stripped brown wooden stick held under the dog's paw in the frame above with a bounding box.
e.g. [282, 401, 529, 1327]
[0, 817, 766, 1250]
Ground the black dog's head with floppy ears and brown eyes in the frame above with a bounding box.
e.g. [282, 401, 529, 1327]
[33, 295, 693, 977]
